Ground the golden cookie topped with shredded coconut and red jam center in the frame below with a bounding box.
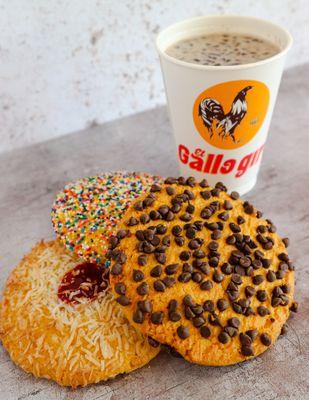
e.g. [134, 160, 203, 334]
[0, 241, 159, 387]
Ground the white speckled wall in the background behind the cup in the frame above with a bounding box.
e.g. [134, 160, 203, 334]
[0, 0, 309, 152]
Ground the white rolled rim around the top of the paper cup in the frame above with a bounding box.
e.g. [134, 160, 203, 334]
[156, 14, 293, 71]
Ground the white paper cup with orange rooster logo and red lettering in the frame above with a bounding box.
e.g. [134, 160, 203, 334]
[156, 15, 292, 194]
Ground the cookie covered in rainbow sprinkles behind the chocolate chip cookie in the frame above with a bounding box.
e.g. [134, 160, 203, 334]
[52, 172, 161, 264]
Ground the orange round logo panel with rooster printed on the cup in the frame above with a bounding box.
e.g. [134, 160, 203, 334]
[193, 80, 269, 149]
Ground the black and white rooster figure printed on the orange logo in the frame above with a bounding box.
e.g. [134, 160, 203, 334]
[198, 86, 253, 143]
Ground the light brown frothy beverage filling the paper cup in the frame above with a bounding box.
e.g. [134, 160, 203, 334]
[166, 33, 280, 65]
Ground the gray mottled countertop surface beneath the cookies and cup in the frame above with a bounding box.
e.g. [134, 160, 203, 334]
[0, 65, 309, 400]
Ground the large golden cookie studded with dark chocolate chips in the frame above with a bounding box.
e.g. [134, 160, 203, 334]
[110, 178, 294, 365]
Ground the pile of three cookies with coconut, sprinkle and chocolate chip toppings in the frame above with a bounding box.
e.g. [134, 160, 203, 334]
[0, 172, 297, 387]
